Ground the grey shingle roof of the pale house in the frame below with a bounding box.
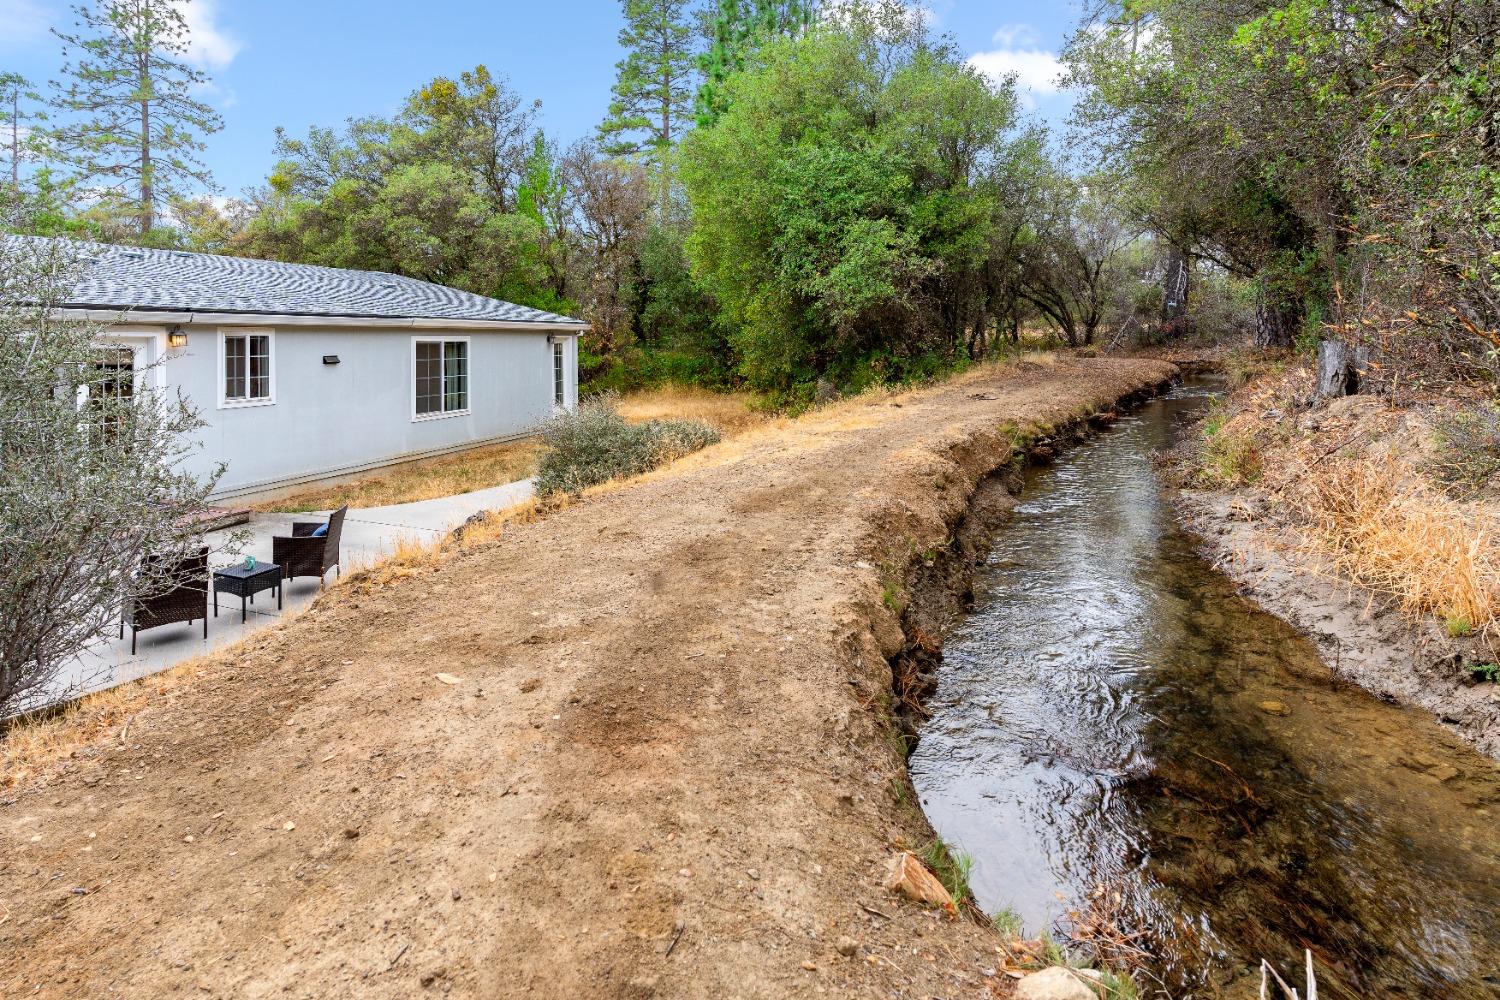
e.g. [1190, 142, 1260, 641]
[27, 236, 578, 325]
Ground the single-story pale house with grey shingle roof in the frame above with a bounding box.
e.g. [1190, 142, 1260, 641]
[41, 244, 585, 501]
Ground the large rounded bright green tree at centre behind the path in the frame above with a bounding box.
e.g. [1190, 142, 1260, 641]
[683, 4, 1022, 391]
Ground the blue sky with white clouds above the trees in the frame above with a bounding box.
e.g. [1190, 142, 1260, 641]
[0, 0, 1077, 195]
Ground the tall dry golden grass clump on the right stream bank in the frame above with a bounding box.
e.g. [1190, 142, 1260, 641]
[1290, 459, 1500, 634]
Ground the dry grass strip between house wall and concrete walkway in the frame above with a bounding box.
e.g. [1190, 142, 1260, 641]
[254, 438, 542, 513]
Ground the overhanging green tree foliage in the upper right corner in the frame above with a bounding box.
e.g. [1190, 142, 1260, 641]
[1067, 0, 1500, 373]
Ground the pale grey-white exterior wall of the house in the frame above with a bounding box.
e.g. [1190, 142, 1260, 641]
[108, 325, 578, 499]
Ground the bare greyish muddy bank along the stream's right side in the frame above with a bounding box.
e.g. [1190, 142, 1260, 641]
[1178, 489, 1500, 759]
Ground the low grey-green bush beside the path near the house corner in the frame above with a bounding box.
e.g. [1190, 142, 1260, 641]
[537, 393, 719, 496]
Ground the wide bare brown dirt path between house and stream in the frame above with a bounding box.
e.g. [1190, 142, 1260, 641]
[0, 358, 1173, 999]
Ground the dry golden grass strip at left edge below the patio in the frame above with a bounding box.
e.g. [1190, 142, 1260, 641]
[0, 657, 209, 790]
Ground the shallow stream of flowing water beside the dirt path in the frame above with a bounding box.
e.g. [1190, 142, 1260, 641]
[911, 385, 1500, 1000]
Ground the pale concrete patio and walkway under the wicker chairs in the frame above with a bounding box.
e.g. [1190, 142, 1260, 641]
[42, 480, 534, 703]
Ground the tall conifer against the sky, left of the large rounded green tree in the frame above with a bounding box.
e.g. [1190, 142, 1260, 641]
[599, 0, 693, 217]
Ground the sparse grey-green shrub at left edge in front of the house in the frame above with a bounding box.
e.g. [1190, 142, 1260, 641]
[0, 237, 228, 715]
